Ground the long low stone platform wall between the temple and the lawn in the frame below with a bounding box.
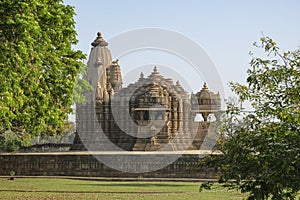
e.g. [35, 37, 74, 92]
[0, 152, 216, 179]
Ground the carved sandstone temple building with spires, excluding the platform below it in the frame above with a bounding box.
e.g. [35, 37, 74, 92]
[71, 33, 221, 151]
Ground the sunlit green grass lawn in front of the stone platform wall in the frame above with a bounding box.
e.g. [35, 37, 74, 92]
[0, 178, 245, 200]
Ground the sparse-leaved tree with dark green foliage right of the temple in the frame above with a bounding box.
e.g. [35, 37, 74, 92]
[203, 37, 300, 199]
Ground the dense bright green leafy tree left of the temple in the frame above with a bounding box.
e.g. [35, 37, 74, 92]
[0, 0, 85, 151]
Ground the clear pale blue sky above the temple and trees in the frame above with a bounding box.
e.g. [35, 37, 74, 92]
[64, 0, 300, 101]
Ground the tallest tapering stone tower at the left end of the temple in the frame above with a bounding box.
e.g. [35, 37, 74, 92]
[71, 32, 112, 150]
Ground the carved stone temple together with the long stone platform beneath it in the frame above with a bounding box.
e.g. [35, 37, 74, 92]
[0, 33, 221, 180]
